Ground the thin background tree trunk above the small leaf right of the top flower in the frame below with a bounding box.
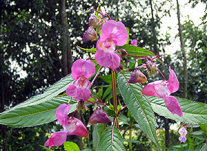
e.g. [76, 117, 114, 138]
[149, 0, 158, 54]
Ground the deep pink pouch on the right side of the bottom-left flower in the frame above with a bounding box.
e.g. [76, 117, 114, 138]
[64, 117, 88, 137]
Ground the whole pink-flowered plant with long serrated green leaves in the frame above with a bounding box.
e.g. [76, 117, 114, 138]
[0, 9, 207, 151]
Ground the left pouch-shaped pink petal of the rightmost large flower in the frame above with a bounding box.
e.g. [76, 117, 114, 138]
[142, 81, 162, 97]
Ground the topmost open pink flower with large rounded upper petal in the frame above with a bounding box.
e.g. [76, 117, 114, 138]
[95, 20, 128, 70]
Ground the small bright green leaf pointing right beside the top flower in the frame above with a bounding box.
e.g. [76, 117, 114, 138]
[117, 44, 155, 56]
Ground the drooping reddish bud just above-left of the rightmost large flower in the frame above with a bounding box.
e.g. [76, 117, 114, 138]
[128, 70, 147, 84]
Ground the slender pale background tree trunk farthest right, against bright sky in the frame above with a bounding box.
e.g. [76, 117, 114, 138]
[176, 0, 188, 98]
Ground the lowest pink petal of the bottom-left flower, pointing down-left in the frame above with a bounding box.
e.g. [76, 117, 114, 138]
[44, 131, 67, 149]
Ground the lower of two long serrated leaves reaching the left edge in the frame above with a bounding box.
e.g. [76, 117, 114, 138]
[0, 96, 77, 127]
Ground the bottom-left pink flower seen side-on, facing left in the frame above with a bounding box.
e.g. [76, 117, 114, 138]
[44, 104, 88, 148]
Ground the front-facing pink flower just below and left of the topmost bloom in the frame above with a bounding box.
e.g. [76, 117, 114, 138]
[66, 59, 95, 101]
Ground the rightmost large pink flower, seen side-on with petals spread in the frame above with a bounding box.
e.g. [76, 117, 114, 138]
[142, 67, 183, 117]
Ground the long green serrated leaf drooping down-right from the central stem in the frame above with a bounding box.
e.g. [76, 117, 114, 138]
[118, 73, 157, 144]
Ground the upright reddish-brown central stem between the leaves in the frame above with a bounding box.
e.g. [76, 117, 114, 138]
[111, 71, 119, 129]
